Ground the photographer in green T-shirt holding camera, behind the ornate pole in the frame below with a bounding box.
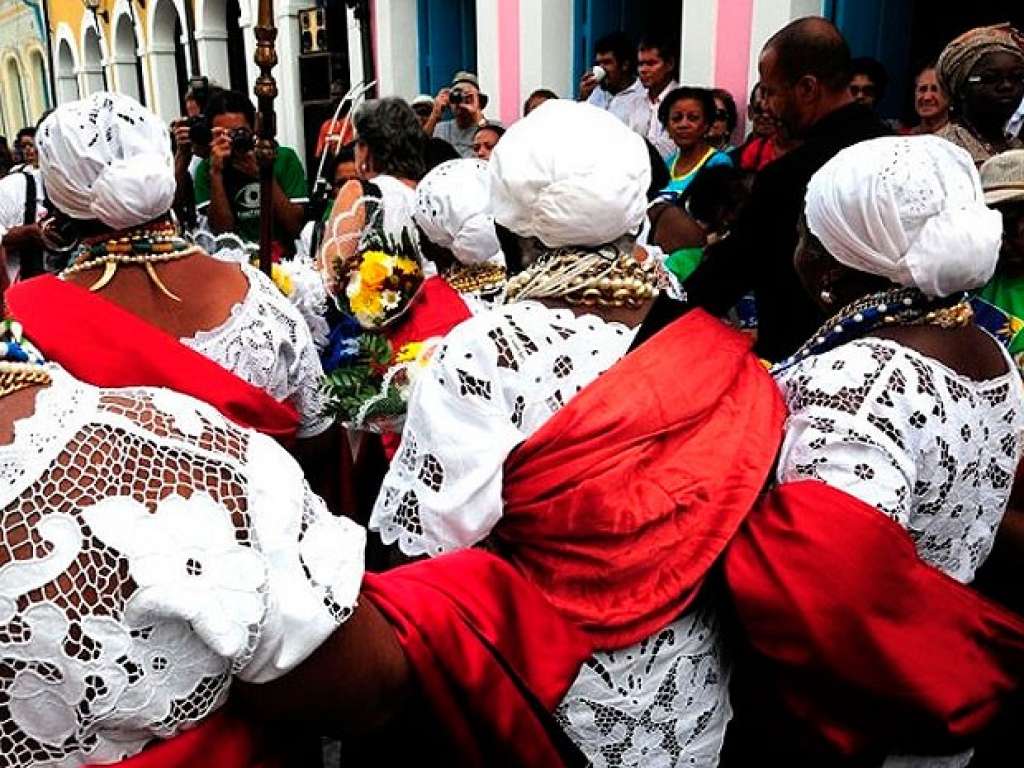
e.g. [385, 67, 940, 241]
[196, 90, 307, 254]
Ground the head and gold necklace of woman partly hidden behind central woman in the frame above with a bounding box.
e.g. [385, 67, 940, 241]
[413, 159, 506, 300]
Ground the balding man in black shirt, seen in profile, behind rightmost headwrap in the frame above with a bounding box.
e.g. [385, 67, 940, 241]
[685, 17, 891, 361]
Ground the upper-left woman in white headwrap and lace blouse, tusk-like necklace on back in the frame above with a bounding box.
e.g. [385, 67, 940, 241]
[8, 92, 332, 448]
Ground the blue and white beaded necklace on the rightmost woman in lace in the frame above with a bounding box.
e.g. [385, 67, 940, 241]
[771, 288, 974, 374]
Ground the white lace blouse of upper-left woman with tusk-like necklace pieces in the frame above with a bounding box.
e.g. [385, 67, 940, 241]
[181, 264, 332, 437]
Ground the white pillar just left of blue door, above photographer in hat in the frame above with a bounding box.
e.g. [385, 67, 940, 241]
[374, 0, 417, 98]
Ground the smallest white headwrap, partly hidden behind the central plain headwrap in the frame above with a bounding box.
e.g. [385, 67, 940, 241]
[414, 159, 501, 264]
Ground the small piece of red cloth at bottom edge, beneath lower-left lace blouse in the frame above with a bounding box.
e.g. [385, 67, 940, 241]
[86, 710, 283, 768]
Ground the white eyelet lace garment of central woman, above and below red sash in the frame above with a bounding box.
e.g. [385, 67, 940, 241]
[370, 301, 731, 768]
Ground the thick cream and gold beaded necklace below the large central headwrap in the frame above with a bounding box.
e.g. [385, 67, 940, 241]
[505, 246, 658, 309]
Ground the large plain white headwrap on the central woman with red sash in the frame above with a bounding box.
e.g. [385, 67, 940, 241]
[490, 99, 650, 248]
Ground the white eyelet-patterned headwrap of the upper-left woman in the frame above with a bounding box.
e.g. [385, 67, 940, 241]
[36, 92, 176, 229]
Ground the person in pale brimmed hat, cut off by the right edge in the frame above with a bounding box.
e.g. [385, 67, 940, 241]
[974, 150, 1024, 372]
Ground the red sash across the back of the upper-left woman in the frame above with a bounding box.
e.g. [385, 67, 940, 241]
[5, 275, 299, 443]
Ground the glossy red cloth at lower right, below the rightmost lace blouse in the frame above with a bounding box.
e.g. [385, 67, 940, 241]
[725, 481, 1024, 756]
